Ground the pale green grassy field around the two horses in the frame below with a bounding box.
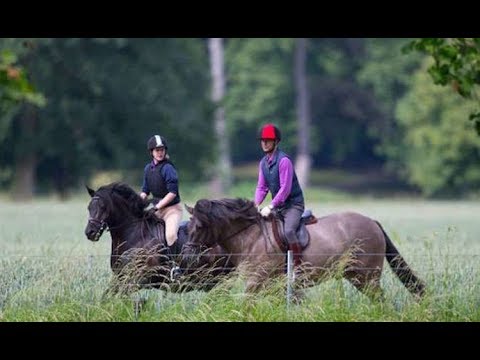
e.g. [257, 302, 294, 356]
[0, 182, 480, 322]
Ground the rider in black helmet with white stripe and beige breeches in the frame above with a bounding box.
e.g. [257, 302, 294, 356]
[140, 135, 183, 246]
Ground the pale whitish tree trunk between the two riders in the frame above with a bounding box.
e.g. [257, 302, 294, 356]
[208, 38, 232, 197]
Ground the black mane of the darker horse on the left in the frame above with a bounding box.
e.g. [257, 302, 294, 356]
[95, 182, 147, 217]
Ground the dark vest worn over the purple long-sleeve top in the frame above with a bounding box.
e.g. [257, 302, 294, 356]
[261, 150, 304, 207]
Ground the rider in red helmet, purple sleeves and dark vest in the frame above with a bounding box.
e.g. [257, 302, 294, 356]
[254, 124, 305, 266]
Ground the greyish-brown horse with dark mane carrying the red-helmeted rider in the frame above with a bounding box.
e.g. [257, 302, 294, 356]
[184, 199, 425, 298]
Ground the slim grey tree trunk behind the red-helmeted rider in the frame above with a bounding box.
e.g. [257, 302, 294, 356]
[294, 38, 311, 187]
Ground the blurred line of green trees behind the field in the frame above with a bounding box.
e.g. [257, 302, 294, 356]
[0, 38, 480, 198]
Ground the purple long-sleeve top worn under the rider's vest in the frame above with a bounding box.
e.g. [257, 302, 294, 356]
[255, 156, 293, 207]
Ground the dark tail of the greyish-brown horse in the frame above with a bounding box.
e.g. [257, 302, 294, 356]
[375, 221, 425, 297]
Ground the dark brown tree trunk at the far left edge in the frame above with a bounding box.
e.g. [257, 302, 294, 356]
[11, 105, 37, 201]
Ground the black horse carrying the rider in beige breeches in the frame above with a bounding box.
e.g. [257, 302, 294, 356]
[85, 182, 230, 293]
